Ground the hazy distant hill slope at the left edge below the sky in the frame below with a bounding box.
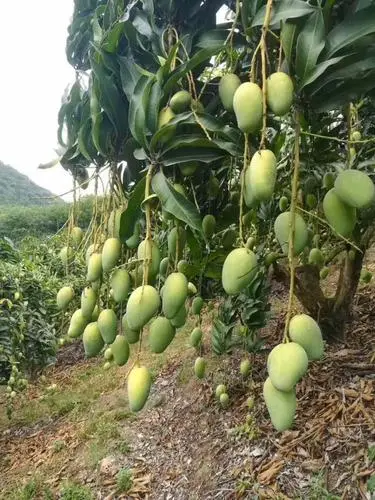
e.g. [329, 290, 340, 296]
[0, 161, 63, 206]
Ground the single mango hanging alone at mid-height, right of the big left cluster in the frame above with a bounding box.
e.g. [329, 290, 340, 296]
[221, 248, 257, 295]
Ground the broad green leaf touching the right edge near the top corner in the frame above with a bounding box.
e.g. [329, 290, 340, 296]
[325, 5, 375, 58]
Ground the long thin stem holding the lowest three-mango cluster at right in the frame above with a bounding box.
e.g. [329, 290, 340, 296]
[283, 111, 301, 342]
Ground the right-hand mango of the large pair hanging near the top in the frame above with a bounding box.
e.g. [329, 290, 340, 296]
[266, 71, 294, 116]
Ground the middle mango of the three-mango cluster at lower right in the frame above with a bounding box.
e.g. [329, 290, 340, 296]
[267, 342, 309, 392]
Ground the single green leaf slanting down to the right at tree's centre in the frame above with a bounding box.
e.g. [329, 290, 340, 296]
[151, 172, 202, 232]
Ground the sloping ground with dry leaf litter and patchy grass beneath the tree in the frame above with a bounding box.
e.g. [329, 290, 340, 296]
[0, 280, 375, 500]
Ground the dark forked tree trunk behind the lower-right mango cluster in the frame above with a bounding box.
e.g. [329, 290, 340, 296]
[274, 252, 364, 341]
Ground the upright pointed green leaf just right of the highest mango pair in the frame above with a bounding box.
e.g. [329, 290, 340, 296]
[296, 10, 325, 80]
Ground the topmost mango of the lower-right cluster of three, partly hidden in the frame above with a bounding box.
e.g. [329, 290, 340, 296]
[289, 314, 324, 360]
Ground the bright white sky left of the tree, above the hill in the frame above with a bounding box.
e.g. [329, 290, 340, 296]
[0, 0, 78, 199]
